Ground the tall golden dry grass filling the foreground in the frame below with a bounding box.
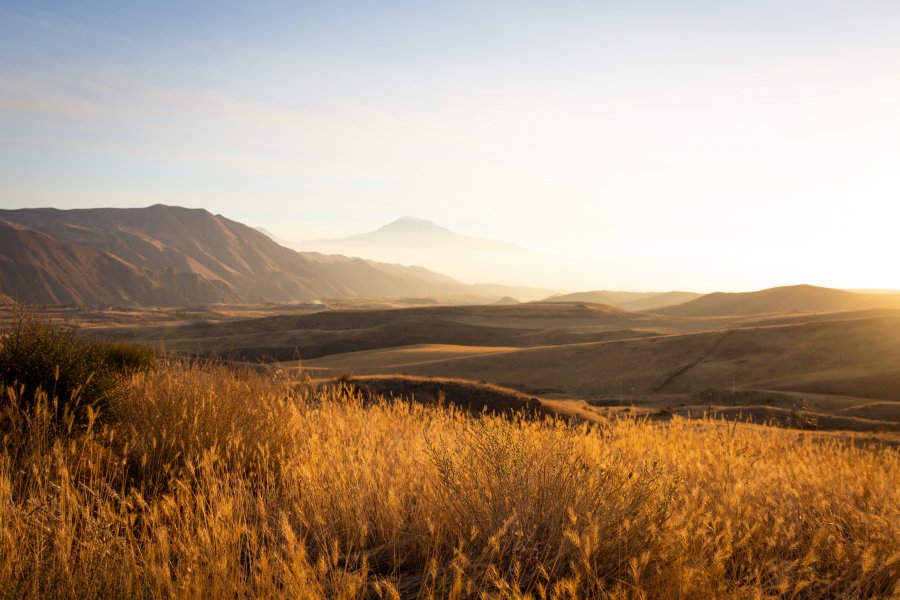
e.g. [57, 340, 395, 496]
[0, 362, 900, 598]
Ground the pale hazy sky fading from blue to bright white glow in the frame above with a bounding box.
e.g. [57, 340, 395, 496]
[0, 0, 900, 291]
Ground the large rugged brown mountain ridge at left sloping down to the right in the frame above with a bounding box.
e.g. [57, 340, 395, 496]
[0, 204, 520, 305]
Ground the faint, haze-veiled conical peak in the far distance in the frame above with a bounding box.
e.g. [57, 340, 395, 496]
[294, 217, 546, 300]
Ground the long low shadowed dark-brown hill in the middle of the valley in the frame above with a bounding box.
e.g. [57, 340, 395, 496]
[105, 304, 659, 361]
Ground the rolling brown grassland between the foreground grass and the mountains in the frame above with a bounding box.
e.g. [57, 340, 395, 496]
[17, 302, 900, 443]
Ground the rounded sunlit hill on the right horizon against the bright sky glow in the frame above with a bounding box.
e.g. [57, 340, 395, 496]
[655, 285, 900, 317]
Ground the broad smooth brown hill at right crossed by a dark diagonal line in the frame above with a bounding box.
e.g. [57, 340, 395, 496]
[382, 313, 900, 402]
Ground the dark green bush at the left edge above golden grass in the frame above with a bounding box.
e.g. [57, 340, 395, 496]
[0, 307, 154, 422]
